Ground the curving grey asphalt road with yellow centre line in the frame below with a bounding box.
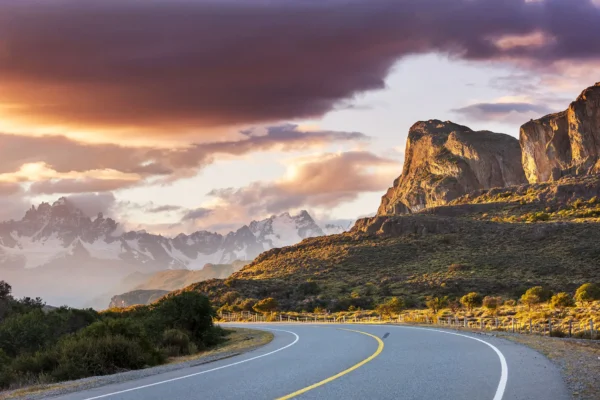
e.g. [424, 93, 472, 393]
[49, 324, 570, 400]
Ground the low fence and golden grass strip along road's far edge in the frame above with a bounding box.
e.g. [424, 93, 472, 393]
[218, 311, 600, 340]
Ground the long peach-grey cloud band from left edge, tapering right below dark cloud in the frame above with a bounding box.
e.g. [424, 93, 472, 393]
[0, 124, 368, 194]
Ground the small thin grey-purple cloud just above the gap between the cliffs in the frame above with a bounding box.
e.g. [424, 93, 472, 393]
[452, 102, 555, 123]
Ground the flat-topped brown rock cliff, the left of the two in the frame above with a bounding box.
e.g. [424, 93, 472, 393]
[377, 120, 526, 215]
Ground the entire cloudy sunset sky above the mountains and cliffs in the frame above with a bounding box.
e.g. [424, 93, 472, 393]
[0, 0, 600, 235]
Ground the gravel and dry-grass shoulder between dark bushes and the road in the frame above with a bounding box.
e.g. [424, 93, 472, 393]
[0, 327, 273, 400]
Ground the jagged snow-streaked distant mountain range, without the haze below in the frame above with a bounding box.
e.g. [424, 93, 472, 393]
[0, 198, 346, 271]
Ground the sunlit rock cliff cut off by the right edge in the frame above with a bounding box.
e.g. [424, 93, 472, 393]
[520, 83, 600, 183]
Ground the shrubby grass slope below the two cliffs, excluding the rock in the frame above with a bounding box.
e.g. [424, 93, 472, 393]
[180, 176, 600, 311]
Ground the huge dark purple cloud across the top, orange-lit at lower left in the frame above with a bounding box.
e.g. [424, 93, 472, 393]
[0, 0, 600, 136]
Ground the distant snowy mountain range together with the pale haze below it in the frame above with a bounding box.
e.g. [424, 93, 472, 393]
[0, 198, 347, 305]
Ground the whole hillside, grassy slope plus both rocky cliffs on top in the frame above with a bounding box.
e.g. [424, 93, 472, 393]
[178, 84, 600, 311]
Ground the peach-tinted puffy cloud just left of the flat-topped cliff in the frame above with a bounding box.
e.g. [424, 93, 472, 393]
[209, 151, 400, 222]
